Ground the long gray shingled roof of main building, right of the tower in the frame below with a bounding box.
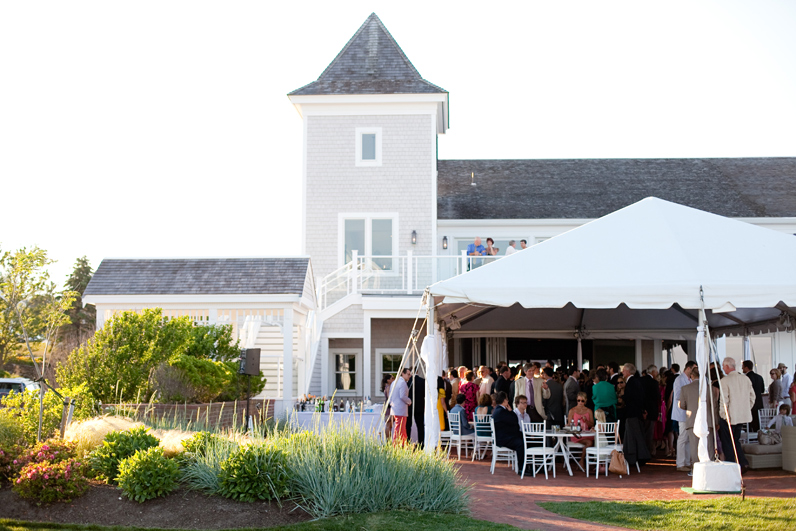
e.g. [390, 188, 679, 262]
[437, 157, 796, 219]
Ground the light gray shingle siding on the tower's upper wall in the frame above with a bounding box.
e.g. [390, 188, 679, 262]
[304, 114, 436, 276]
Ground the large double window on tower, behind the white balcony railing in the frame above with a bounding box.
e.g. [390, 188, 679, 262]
[340, 214, 398, 271]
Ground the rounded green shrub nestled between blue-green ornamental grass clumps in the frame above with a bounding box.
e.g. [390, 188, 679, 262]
[218, 445, 290, 502]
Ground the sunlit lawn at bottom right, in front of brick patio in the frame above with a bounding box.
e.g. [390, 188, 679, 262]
[539, 498, 796, 531]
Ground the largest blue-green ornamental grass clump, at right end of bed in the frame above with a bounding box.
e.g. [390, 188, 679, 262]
[274, 424, 469, 518]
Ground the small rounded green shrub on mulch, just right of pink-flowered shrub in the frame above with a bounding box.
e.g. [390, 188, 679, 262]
[117, 447, 180, 503]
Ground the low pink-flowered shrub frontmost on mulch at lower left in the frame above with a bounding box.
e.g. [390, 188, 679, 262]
[13, 458, 89, 504]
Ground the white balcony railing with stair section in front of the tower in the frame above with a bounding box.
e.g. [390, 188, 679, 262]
[318, 251, 498, 310]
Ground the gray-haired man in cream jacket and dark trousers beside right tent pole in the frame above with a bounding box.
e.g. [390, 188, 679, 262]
[719, 356, 755, 472]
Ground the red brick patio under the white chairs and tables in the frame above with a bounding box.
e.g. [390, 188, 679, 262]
[460, 450, 796, 531]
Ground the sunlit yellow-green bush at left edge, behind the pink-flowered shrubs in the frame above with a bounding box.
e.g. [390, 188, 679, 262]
[0, 385, 94, 444]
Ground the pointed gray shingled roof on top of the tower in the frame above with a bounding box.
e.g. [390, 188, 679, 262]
[288, 13, 447, 96]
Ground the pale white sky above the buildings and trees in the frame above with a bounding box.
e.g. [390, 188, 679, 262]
[0, 0, 796, 283]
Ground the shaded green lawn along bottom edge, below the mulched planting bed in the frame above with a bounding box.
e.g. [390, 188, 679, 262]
[0, 511, 518, 531]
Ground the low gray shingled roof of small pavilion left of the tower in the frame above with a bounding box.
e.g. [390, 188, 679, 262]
[83, 258, 309, 298]
